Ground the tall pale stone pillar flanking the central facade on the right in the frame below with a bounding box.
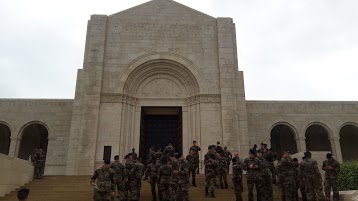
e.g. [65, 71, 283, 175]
[217, 18, 240, 152]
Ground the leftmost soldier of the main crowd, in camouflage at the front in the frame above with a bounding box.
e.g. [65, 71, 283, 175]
[90, 160, 116, 201]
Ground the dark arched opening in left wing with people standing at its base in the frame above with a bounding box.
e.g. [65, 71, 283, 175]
[18, 123, 48, 160]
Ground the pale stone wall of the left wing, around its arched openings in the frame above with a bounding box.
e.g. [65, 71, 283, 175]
[0, 99, 73, 175]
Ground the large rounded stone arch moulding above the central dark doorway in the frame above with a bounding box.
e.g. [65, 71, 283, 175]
[116, 53, 208, 94]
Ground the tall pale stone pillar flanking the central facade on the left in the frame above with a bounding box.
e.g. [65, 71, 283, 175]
[66, 15, 108, 175]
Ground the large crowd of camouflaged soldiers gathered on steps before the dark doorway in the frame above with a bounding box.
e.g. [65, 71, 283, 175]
[90, 141, 339, 201]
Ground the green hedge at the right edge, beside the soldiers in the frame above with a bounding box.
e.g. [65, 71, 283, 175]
[339, 161, 358, 191]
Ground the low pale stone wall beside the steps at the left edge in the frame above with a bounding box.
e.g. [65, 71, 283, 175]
[0, 154, 34, 197]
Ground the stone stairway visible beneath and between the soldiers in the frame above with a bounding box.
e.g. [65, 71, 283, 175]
[0, 175, 281, 201]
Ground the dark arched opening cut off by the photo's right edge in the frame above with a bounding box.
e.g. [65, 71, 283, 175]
[339, 124, 358, 161]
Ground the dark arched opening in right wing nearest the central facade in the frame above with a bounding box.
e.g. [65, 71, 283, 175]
[270, 124, 297, 157]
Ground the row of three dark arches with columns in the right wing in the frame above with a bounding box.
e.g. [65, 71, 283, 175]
[270, 122, 358, 161]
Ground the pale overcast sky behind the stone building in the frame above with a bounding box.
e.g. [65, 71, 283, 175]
[0, 0, 358, 101]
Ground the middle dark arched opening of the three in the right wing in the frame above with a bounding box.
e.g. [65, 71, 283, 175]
[305, 124, 332, 151]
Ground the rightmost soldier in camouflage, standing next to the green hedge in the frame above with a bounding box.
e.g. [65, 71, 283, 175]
[322, 153, 340, 201]
